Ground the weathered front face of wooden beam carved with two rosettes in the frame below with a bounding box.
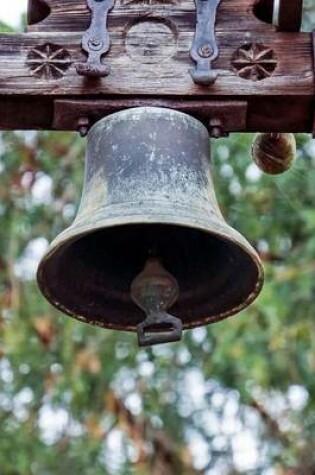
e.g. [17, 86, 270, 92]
[0, 31, 314, 98]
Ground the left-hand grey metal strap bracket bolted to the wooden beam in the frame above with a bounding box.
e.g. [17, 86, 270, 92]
[76, 0, 115, 77]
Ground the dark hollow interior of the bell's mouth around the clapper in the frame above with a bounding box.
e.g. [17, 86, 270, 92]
[37, 223, 263, 331]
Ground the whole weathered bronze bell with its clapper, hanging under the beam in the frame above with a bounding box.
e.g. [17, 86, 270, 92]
[37, 107, 263, 345]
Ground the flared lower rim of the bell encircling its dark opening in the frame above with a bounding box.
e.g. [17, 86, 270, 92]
[36, 206, 264, 332]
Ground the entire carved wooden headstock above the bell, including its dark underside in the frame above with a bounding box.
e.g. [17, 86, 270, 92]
[0, 0, 314, 132]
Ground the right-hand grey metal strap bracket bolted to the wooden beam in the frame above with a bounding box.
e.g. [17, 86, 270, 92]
[189, 0, 221, 86]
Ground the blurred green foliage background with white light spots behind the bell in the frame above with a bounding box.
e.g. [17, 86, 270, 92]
[0, 0, 315, 475]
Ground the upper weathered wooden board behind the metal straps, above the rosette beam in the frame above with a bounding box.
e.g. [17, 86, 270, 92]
[28, 0, 274, 32]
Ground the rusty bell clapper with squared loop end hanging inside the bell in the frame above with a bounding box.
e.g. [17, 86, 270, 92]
[131, 257, 183, 346]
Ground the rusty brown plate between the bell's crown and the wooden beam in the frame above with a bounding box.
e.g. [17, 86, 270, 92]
[53, 98, 248, 133]
